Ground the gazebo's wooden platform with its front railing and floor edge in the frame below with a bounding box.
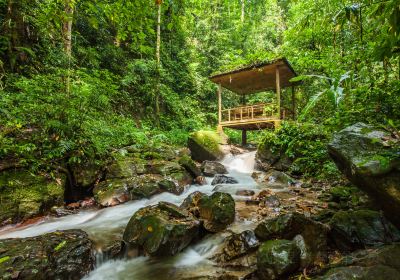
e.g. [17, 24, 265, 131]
[220, 103, 281, 130]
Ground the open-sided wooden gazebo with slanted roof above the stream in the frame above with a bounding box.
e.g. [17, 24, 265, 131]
[210, 58, 297, 145]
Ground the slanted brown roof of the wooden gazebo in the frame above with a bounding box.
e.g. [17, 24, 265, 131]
[210, 58, 298, 95]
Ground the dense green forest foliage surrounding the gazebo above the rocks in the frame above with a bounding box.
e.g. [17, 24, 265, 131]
[0, 0, 400, 178]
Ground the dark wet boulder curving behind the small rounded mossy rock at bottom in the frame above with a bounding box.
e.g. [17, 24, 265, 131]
[255, 213, 328, 267]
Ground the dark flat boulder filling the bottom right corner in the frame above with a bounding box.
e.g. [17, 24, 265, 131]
[315, 244, 400, 280]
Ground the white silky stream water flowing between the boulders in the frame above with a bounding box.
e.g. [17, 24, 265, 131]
[0, 152, 259, 280]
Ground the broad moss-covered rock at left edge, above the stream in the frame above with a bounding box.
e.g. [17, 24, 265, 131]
[0, 169, 65, 225]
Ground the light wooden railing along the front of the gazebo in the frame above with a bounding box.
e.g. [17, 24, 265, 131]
[221, 103, 279, 123]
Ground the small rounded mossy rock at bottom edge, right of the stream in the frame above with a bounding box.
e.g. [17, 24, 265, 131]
[257, 240, 300, 280]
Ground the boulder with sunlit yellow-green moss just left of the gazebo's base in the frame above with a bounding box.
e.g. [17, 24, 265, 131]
[188, 130, 225, 161]
